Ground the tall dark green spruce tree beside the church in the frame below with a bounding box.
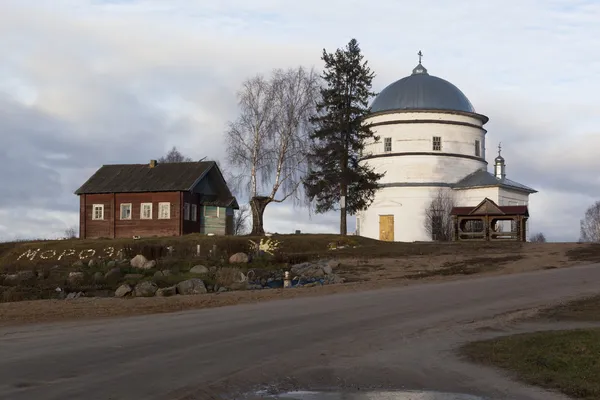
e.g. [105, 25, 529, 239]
[304, 39, 384, 235]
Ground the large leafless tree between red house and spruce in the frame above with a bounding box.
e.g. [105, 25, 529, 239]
[227, 67, 319, 235]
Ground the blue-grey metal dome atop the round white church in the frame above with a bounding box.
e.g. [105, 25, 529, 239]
[371, 64, 475, 113]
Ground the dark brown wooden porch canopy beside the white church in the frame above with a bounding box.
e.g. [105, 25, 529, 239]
[451, 197, 529, 242]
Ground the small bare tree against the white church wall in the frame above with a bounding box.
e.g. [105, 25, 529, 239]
[424, 188, 454, 242]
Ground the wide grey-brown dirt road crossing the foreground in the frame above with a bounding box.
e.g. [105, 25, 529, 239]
[0, 265, 600, 400]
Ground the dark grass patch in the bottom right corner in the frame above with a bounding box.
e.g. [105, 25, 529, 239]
[463, 329, 600, 400]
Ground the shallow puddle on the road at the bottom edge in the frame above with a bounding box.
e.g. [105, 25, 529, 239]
[251, 391, 485, 400]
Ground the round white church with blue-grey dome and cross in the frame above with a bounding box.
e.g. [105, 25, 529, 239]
[356, 56, 536, 242]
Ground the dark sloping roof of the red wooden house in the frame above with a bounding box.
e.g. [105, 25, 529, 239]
[75, 161, 216, 194]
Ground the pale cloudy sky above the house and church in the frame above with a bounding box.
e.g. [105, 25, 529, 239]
[0, 0, 600, 241]
